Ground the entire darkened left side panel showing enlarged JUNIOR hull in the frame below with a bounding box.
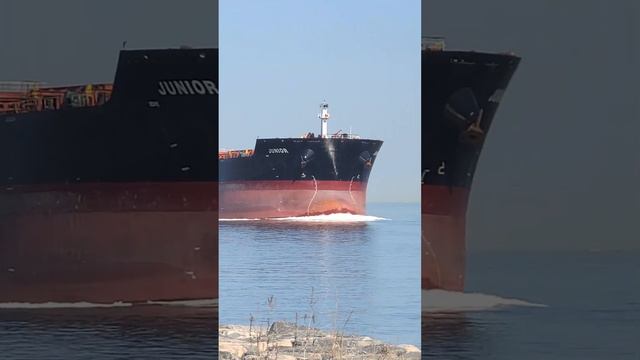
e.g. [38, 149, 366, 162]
[0, 0, 218, 359]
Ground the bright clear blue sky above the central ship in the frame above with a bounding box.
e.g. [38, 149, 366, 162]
[219, 0, 421, 202]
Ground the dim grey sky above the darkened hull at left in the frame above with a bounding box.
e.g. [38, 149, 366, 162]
[0, 0, 218, 84]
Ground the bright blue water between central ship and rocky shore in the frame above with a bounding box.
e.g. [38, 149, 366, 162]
[220, 204, 420, 345]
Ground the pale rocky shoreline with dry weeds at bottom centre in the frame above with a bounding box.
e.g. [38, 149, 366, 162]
[219, 322, 421, 360]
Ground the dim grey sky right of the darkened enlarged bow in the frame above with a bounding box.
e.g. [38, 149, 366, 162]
[422, 0, 640, 249]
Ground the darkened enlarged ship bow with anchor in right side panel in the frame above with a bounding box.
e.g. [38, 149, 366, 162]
[422, 37, 520, 291]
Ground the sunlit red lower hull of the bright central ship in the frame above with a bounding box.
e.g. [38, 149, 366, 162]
[220, 180, 366, 219]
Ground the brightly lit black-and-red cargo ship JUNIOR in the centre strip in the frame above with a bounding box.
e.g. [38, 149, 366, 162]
[218, 102, 382, 219]
